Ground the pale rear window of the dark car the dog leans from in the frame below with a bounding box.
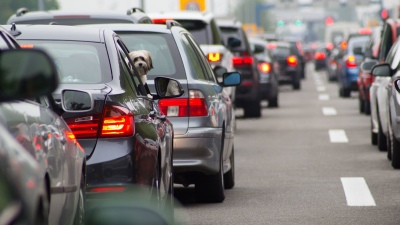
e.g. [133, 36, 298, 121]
[18, 40, 112, 83]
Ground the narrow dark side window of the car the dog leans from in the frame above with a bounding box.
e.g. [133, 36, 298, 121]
[117, 40, 148, 96]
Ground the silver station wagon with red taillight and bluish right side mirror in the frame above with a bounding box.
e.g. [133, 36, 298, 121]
[81, 20, 241, 202]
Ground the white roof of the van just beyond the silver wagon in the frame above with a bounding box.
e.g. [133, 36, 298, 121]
[147, 10, 214, 23]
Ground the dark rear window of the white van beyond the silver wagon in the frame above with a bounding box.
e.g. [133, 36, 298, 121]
[177, 20, 208, 44]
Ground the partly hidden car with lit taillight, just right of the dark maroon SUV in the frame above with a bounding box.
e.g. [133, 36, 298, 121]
[249, 38, 279, 107]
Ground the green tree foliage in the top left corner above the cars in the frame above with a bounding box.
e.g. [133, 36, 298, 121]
[0, 0, 59, 24]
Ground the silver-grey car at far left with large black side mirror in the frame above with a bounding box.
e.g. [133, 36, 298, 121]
[0, 26, 86, 225]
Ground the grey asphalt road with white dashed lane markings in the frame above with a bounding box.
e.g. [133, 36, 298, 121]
[175, 64, 400, 225]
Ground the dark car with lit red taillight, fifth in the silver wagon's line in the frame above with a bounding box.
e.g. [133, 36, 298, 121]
[267, 41, 301, 90]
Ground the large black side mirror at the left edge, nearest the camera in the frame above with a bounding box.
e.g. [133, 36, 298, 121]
[0, 49, 59, 101]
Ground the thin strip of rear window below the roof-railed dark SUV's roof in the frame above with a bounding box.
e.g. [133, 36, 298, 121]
[15, 18, 134, 25]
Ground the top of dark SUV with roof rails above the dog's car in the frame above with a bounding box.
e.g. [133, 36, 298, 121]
[7, 8, 153, 25]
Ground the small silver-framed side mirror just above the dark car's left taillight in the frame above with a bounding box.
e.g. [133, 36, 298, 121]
[61, 89, 94, 112]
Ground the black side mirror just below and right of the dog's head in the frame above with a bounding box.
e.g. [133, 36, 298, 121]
[153, 77, 185, 99]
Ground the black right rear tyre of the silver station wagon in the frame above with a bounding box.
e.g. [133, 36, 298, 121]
[195, 155, 225, 203]
